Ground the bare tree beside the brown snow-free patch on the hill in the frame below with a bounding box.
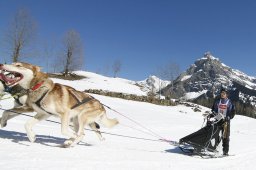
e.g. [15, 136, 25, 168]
[63, 30, 84, 75]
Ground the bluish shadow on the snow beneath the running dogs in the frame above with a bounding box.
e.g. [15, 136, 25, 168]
[0, 129, 66, 146]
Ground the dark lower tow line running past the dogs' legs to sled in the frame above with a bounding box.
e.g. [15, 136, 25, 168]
[0, 107, 169, 142]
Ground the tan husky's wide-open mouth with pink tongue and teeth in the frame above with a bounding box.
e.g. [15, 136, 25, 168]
[0, 69, 23, 86]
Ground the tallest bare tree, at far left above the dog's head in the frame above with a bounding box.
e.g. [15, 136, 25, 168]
[4, 9, 36, 62]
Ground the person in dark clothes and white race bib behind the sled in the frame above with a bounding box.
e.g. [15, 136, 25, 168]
[212, 88, 235, 155]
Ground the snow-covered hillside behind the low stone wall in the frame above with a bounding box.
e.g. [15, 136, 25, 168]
[49, 71, 170, 96]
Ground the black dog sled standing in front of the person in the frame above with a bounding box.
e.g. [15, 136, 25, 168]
[179, 113, 223, 156]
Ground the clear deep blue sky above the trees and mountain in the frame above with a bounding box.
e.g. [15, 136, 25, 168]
[0, 0, 256, 80]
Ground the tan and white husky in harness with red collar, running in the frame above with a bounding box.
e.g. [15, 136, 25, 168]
[0, 62, 118, 147]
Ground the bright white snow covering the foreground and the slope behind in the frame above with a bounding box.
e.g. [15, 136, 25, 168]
[0, 71, 256, 170]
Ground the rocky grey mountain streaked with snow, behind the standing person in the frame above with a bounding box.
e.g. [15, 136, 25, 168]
[162, 52, 256, 115]
